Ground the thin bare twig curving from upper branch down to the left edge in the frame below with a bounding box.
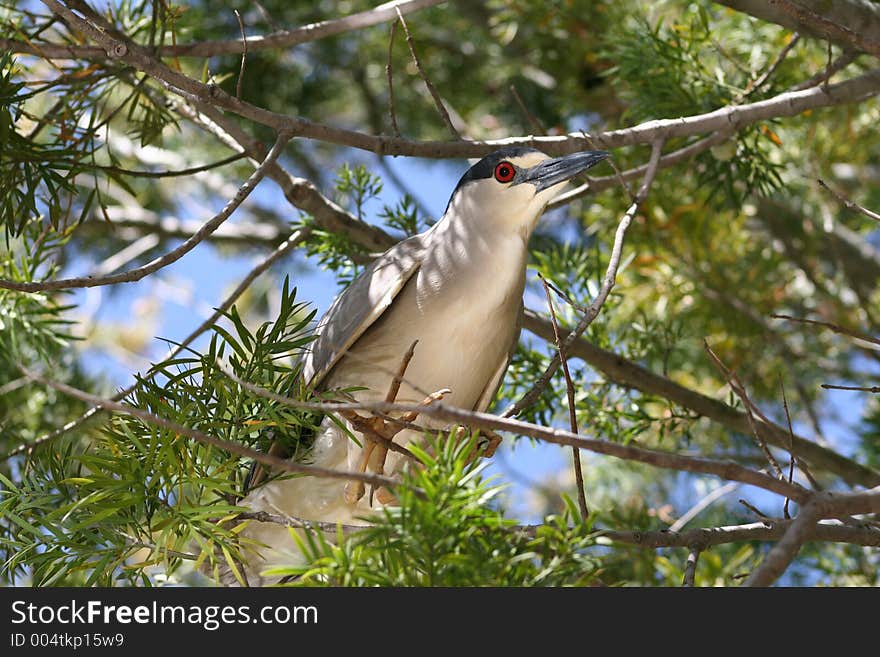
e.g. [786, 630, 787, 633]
[0, 133, 290, 292]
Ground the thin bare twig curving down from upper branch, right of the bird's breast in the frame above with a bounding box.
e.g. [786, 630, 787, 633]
[502, 141, 663, 417]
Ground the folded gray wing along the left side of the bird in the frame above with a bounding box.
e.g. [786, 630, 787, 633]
[303, 235, 425, 387]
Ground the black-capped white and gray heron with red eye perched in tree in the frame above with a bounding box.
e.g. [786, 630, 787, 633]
[232, 146, 609, 585]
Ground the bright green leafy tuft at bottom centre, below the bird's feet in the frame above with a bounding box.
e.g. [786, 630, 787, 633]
[267, 439, 598, 586]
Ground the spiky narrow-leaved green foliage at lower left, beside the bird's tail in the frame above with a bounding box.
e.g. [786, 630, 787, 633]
[0, 283, 319, 586]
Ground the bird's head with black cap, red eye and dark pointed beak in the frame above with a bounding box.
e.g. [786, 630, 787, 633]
[446, 146, 608, 235]
